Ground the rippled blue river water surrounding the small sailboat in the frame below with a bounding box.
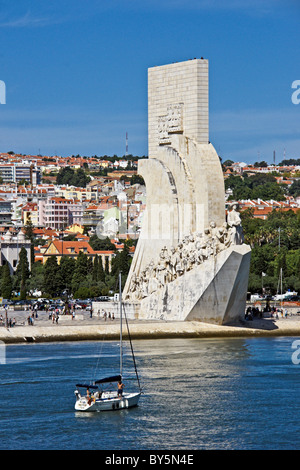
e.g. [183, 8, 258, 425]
[0, 337, 300, 450]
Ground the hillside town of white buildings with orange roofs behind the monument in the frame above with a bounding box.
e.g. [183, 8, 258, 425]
[0, 152, 300, 302]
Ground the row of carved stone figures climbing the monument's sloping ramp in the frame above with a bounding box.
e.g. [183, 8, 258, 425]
[126, 205, 244, 301]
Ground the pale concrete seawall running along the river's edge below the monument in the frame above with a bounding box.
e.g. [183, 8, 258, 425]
[0, 319, 300, 344]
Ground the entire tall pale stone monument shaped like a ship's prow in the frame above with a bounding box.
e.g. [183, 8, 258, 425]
[123, 59, 251, 324]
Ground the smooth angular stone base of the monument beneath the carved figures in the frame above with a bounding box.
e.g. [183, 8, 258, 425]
[138, 244, 251, 325]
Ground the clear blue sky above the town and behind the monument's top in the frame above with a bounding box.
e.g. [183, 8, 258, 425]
[0, 0, 300, 163]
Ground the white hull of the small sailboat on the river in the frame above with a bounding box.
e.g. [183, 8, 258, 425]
[75, 392, 141, 412]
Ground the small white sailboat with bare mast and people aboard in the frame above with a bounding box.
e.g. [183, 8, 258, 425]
[74, 273, 142, 412]
